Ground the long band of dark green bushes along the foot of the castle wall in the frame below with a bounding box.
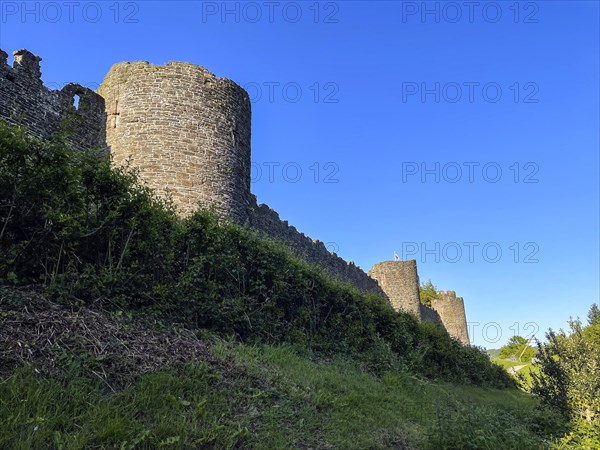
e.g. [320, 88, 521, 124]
[0, 123, 512, 387]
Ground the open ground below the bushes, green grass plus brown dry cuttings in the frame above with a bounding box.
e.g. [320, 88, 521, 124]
[0, 289, 554, 449]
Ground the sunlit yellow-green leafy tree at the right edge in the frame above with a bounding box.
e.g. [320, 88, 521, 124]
[531, 307, 600, 427]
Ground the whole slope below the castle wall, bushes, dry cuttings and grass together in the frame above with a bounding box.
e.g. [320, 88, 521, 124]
[0, 122, 572, 449]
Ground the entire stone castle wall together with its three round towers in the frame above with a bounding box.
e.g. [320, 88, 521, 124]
[0, 50, 469, 345]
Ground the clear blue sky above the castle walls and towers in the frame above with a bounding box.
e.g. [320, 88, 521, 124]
[0, 1, 600, 348]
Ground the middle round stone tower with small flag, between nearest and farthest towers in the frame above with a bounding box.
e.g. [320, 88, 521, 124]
[369, 259, 421, 319]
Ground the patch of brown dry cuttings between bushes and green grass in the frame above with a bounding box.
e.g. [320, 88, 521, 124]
[0, 287, 239, 391]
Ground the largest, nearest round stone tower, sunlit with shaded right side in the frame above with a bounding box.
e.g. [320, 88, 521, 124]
[98, 62, 251, 222]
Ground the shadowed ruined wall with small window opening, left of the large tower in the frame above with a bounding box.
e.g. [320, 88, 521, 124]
[0, 50, 106, 149]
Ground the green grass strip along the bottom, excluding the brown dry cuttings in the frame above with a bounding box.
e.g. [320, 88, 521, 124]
[0, 342, 556, 449]
